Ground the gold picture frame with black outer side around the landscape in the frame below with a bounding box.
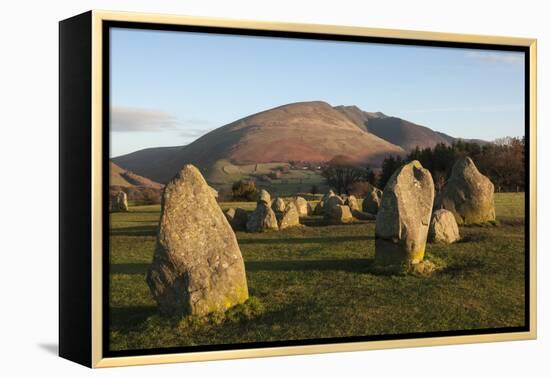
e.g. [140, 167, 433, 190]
[60, 10, 537, 368]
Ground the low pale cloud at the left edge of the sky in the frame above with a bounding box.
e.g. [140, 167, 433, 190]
[111, 106, 179, 132]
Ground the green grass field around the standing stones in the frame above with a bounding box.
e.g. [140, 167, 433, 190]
[109, 193, 525, 350]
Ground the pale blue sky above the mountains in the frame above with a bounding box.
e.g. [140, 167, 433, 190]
[110, 28, 524, 157]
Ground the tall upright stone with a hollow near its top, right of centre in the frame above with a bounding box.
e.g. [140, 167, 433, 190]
[375, 160, 434, 267]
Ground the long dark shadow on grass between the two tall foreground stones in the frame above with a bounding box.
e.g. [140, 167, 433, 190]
[245, 259, 374, 273]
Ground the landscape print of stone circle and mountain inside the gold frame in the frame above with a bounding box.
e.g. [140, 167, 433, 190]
[105, 27, 528, 355]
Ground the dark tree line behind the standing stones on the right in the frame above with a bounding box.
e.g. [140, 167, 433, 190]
[322, 137, 525, 195]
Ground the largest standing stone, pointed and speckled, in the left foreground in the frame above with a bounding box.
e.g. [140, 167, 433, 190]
[147, 165, 248, 316]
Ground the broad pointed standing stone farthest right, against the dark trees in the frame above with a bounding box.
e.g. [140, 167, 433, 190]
[435, 157, 495, 224]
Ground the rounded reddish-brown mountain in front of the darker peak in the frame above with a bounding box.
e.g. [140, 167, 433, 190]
[113, 101, 405, 183]
